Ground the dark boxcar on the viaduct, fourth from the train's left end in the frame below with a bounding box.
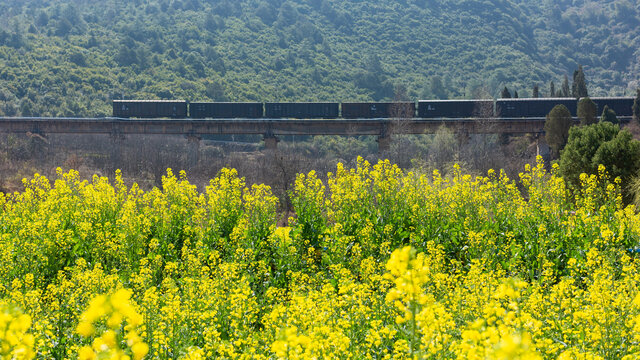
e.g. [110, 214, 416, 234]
[342, 102, 416, 119]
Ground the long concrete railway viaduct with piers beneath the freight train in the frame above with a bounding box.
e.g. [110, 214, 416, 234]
[0, 117, 577, 160]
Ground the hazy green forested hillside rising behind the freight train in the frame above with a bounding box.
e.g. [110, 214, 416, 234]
[0, 0, 640, 116]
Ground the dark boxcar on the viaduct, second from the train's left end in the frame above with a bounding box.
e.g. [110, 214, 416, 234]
[189, 102, 264, 119]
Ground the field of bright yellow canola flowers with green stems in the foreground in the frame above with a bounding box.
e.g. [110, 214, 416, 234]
[0, 160, 640, 359]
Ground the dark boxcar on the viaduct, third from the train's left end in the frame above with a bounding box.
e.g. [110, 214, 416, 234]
[264, 103, 339, 119]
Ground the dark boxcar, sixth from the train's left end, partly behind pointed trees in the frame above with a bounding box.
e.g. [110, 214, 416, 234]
[496, 98, 578, 118]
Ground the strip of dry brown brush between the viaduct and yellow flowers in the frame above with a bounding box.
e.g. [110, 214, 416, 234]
[0, 128, 535, 211]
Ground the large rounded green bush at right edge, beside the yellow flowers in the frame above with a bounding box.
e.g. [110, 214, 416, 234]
[560, 122, 640, 199]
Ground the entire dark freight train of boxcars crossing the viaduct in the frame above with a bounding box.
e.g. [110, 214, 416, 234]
[113, 97, 634, 119]
